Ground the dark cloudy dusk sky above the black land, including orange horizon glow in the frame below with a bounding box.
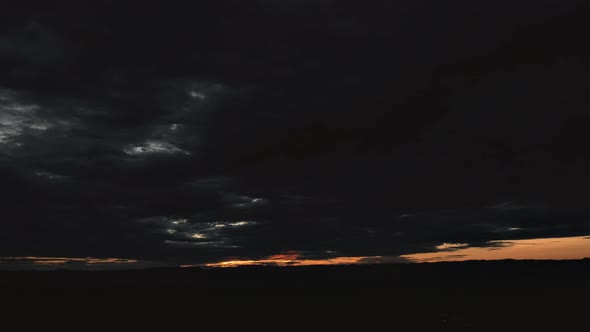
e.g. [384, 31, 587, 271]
[0, 0, 590, 268]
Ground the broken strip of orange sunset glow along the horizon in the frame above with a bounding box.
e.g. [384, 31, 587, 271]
[5, 236, 590, 268]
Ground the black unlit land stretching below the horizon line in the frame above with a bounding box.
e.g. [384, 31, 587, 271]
[0, 260, 590, 331]
